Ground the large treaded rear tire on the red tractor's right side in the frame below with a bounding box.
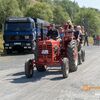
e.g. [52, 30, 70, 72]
[67, 41, 78, 72]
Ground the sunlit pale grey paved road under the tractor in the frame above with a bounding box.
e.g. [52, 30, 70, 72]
[0, 46, 100, 100]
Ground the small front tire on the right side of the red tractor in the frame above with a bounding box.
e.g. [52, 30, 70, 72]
[62, 58, 69, 78]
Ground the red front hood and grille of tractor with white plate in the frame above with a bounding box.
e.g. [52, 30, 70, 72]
[37, 40, 60, 66]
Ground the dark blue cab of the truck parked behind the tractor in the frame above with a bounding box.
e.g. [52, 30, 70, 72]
[3, 17, 36, 53]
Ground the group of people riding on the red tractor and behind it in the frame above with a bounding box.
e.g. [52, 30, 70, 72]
[47, 20, 89, 46]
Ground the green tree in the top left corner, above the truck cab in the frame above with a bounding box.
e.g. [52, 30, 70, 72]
[0, 0, 22, 29]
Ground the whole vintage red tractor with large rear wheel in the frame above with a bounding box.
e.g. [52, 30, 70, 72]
[25, 23, 85, 78]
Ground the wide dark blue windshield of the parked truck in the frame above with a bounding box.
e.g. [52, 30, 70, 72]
[5, 22, 32, 31]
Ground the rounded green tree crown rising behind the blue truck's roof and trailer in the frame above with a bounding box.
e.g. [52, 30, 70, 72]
[25, 2, 53, 21]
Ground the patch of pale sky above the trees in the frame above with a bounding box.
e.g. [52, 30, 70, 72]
[71, 0, 100, 10]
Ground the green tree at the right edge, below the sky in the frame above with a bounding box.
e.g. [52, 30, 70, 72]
[75, 8, 100, 34]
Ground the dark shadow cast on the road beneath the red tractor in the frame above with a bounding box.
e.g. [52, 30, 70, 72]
[9, 70, 63, 84]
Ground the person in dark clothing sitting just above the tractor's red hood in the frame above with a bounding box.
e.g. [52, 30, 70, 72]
[47, 24, 60, 40]
